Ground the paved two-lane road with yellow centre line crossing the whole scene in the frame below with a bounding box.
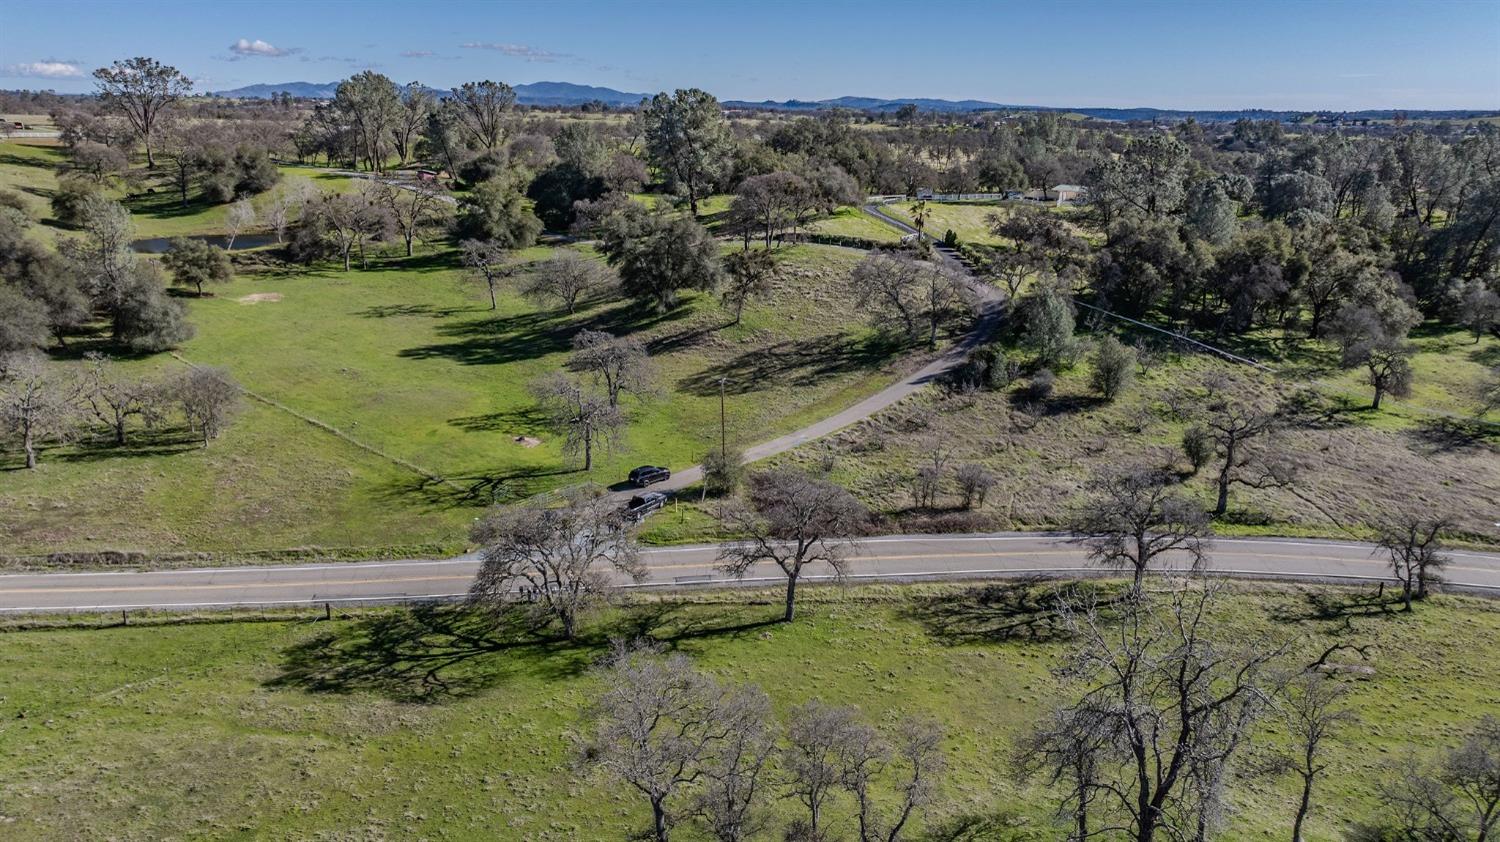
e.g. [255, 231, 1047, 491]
[0, 534, 1500, 612]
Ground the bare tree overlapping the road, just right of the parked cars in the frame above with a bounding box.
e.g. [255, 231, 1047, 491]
[719, 468, 869, 623]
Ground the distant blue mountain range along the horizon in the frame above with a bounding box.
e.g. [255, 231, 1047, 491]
[216, 83, 1500, 123]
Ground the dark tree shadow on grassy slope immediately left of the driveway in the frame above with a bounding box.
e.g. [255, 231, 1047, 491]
[678, 333, 906, 396]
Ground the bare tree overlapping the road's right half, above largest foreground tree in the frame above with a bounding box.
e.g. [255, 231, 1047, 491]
[1071, 467, 1209, 591]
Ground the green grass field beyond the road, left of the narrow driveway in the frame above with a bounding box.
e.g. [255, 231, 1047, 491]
[0, 234, 903, 554]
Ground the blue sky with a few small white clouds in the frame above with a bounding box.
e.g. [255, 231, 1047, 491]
[0, 0, 1500, 110]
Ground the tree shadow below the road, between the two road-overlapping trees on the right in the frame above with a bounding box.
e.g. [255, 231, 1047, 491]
[906, 576, 1071, 645]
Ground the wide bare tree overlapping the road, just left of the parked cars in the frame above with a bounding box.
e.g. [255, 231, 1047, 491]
[470, 489, 647, 639]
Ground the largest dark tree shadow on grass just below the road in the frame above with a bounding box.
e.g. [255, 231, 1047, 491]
[266, 603, 777, 704]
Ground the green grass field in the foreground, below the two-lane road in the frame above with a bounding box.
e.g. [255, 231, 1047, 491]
[0, 585, 1500, 842]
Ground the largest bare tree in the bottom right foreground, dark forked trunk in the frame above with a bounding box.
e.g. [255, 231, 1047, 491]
[1020, 587, 1281, 842]
